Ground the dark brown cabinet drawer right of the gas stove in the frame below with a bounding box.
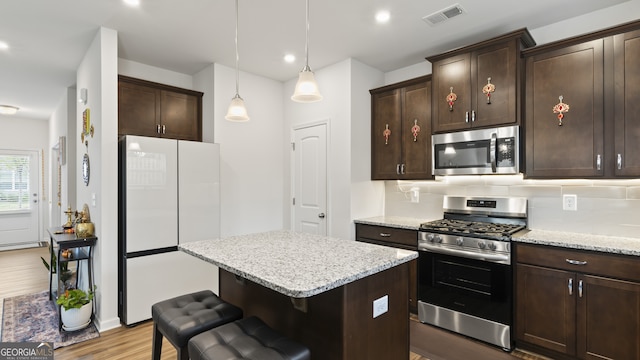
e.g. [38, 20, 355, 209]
[516, 244, 640, 281]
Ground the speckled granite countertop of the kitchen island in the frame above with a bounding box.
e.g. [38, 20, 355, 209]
[178, 230, 418, 298]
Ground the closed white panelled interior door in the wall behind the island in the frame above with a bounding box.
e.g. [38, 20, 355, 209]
[292, 124, 328, 235]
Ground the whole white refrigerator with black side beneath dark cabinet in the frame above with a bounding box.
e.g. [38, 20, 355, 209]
[118, 135, 220, 325]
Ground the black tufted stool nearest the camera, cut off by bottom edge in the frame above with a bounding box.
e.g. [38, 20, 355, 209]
[188, 316, 311, 360]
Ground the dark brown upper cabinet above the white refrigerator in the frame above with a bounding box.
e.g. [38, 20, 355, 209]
[118, 75, 203, 141]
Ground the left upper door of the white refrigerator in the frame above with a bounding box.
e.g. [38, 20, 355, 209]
[125, 136, 178, 253]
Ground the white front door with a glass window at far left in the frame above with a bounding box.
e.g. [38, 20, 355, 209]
[0, 150, 41, 247]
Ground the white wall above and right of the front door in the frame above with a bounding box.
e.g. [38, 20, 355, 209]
[0, 115, 51, 241]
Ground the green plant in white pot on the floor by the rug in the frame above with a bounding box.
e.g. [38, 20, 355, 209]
[56, 286, 96, 331]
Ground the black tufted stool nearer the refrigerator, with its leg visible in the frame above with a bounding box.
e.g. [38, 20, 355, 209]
[151, 290, 242, 360]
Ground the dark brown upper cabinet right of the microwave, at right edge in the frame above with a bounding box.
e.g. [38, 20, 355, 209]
[523, 22, 640, 178]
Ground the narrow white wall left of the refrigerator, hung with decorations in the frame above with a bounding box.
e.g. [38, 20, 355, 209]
[75, 28, 120, 331]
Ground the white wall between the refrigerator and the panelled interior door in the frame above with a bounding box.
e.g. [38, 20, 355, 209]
[213, 64, 285, 236]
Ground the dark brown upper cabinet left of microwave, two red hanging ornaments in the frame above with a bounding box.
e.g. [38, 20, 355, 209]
[369, 75, 433, 180]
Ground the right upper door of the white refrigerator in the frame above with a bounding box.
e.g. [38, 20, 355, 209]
[178, 141, 220, 243]
